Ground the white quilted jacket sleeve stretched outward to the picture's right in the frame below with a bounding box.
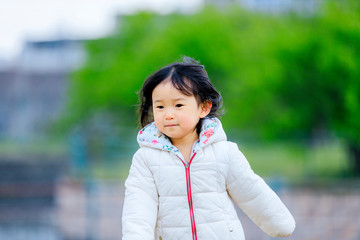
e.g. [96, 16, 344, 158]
[227, 143, 295, 237]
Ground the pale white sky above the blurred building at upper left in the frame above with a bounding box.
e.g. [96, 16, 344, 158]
[0, 0, 203, 60]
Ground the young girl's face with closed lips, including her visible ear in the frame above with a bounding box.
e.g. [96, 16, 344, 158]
[152, 79, 211, 144]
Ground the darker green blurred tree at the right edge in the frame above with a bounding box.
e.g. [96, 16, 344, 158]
[263, 1, 360, 173]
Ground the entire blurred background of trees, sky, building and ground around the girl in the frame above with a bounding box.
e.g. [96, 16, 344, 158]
[0, 0, 360, 240]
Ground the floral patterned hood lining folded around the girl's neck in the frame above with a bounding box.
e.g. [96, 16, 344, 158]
[137, 118, 226, 159]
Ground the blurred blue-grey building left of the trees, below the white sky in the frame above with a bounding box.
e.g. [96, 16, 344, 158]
[0, 39, 86, 139]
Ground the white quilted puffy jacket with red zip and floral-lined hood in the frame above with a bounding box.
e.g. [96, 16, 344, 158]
[122, 118, 295, 240]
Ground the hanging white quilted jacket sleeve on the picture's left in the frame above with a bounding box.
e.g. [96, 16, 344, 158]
[122, 149, 158, 240]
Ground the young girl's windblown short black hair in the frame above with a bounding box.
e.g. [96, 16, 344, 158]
[139, 57, 222, 134]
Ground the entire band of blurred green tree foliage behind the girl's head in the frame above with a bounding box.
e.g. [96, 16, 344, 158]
[68, 1, 360, 147]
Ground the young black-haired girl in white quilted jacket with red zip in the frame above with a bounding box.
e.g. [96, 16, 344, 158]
[122, 58, 295, 240]
